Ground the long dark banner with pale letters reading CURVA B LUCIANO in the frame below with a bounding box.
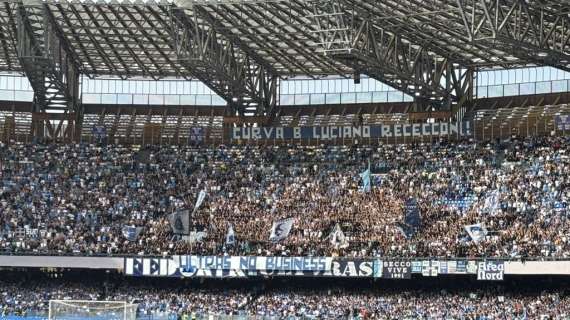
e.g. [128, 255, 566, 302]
[230, 121, 472, 140]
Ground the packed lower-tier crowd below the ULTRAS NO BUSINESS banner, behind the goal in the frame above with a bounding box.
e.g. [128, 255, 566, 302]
[0, 282, 570, 320]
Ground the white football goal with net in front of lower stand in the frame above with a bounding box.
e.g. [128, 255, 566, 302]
[48, 300, 137, 320]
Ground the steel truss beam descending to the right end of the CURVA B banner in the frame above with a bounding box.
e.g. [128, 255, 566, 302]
[306, 0, 469, 108]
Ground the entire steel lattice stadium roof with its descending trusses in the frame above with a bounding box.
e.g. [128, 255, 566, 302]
[0, 0, 570, 119]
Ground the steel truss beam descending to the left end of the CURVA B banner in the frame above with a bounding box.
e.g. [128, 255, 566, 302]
[171, 8, 279, 118]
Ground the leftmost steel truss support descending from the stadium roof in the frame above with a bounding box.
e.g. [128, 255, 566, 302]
[17, 0, 82, 139]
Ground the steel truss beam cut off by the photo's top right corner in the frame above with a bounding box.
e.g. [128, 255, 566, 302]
[444, 0, 570, 71]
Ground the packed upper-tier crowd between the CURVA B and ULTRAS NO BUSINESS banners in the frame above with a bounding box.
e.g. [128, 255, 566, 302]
[0, 137, 570, 257]
